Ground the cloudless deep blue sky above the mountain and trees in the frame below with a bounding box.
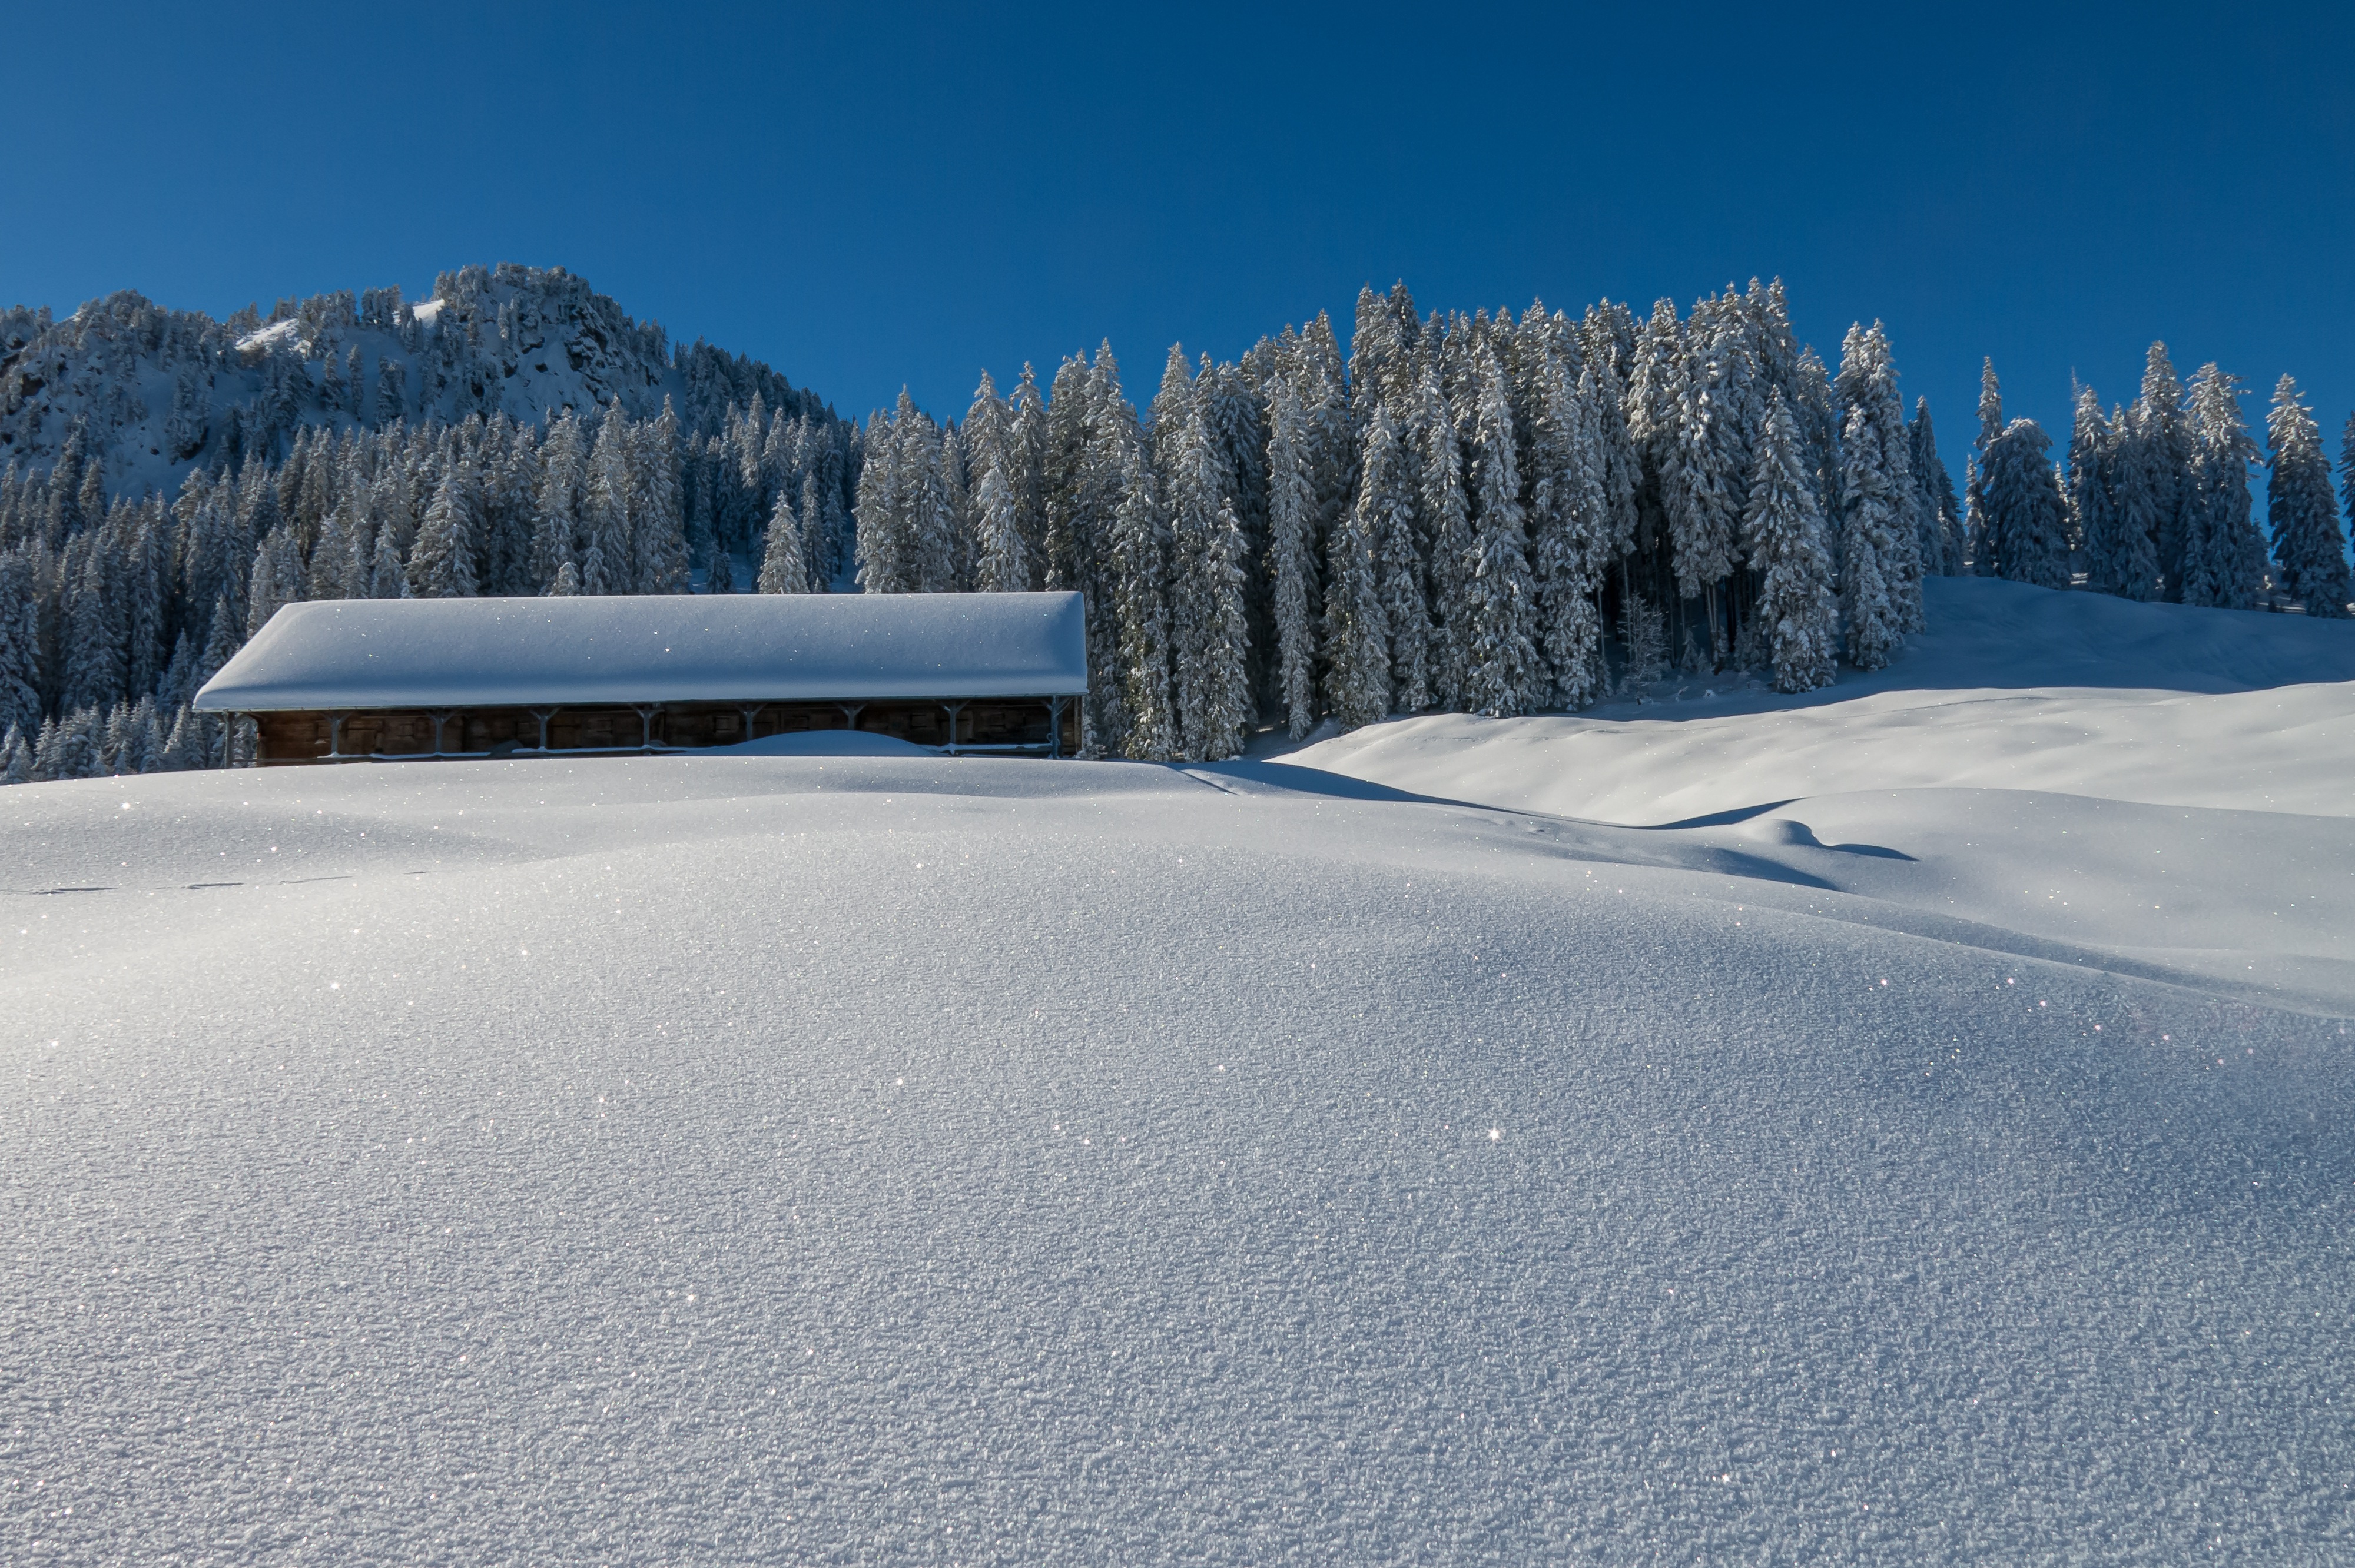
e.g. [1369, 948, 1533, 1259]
[0, 5, 2355, 480]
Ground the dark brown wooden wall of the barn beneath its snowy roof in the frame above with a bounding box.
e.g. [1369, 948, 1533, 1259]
[250, 697, 1079, 768]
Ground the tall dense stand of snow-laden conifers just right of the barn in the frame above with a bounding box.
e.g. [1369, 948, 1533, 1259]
[857, 280, 1966, 758]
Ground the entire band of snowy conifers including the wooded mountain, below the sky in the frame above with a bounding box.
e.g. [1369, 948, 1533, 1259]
[0, 266, 2355, 782]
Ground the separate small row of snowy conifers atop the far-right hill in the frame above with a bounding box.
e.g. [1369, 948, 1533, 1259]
[1964, 344, 2355, 619]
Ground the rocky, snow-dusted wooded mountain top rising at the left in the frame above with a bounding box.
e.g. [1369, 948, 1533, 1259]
[0, 264, 831, 497]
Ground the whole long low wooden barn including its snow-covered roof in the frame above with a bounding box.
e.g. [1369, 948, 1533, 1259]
[195, 593, 1088, 768]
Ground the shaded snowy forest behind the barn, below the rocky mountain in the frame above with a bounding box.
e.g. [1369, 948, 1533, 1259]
[0, 393, 860, 782]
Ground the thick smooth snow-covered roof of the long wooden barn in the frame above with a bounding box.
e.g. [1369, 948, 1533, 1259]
[195, 593, 1088, 713]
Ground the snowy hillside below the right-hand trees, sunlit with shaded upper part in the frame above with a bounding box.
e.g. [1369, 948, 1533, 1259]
[1267, 577, 2355, 822]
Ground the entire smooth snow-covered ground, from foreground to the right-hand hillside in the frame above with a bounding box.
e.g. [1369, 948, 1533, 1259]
[14, 584, 2355, 1563]
